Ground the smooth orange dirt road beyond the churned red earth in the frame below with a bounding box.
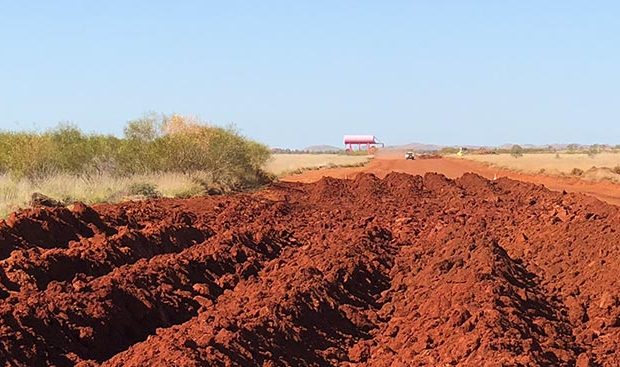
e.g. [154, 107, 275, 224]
[282, 156, 620, 205]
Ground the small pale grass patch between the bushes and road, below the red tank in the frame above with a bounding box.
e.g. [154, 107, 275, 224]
[265, 154, 371, 176]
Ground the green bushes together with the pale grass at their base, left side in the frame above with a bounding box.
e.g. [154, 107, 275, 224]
[0, 114, 272, 215]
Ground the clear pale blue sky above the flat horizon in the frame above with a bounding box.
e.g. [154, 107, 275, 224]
[0, 0, 620, 147]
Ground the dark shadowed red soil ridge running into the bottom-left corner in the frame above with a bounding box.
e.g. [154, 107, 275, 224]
[0, 229, 295, 365]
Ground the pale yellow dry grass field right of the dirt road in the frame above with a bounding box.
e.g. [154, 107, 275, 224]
[465, 153, 620, 182]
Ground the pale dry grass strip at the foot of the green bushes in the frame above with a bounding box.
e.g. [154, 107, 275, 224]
[0, 173, 203, 217]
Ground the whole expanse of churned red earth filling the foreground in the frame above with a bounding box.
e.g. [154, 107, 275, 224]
[0, 173, 620, 367]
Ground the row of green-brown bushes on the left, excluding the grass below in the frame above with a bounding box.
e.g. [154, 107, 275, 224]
[0, 114, 272, 190]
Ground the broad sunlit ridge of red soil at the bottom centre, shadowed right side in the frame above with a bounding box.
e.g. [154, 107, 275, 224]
[103, 227, 397, 366]
